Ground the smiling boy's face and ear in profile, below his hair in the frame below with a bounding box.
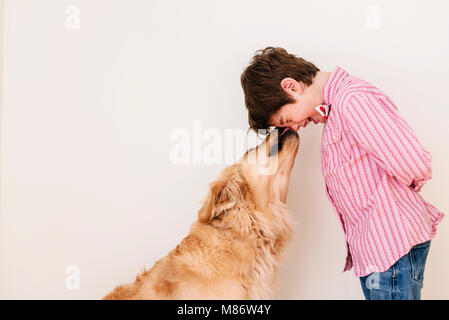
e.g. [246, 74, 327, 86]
[270, 78, 326, 131]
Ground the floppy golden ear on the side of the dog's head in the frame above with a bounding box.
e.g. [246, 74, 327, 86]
[198, 167, 248, 223]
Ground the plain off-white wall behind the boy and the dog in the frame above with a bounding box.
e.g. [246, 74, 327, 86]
[0, 0, 449, 299]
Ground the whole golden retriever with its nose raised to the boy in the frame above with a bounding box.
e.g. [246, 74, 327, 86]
[103, 128, 300, 300]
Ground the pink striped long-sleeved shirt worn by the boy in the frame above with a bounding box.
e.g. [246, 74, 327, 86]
[321, 66, 444, 277]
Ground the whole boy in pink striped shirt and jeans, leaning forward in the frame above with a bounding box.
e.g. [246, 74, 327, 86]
[241, 47, 444, 300]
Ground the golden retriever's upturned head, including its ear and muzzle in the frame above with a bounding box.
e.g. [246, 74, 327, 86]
[198, 128, 300, 222]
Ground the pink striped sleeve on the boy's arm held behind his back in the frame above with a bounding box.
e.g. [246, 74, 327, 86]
[343, 93, 432, 190]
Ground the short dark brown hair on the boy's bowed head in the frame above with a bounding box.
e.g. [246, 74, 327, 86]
[240, 47, 320, 130]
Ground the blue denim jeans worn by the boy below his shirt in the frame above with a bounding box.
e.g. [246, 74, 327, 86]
[360, 240, 431, 300]
